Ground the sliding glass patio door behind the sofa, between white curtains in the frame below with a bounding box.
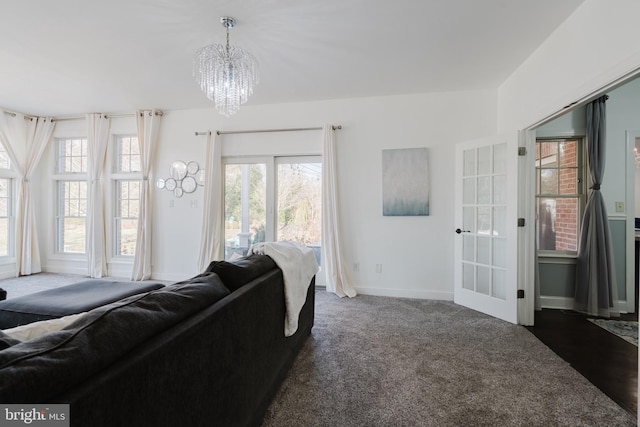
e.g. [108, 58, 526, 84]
[224, 156, 322, 263]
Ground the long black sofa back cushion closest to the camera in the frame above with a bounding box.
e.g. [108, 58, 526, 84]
[0, 275, 229, 403]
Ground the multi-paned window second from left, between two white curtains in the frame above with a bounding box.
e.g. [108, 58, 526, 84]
[54, 138, 88, 253]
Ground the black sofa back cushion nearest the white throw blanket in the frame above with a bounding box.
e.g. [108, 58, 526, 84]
[205, 254, 278, 292]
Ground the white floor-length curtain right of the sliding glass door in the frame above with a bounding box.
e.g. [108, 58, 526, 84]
[322, 125, 356, 298]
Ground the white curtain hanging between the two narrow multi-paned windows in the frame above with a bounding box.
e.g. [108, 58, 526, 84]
[86, 113, 111, 277]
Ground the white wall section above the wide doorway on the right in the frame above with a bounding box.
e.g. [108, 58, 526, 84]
[498, 0, 640, 132]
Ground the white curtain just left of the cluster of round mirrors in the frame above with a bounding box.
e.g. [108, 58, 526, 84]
[131, 110, 162, 280]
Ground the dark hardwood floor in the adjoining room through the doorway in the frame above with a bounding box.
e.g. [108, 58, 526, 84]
[527, 309, 638, 416]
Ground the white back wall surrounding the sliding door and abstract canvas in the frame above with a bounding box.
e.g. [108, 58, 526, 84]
[39, 90, 497, 299]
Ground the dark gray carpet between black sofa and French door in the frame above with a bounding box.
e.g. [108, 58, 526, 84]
[263, 292, 636, 427]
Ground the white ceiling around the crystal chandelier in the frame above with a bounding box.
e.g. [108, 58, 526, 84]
[0, 0, 584, 116]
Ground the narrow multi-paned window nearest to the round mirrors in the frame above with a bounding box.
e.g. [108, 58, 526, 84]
[112, 136, 142, 256]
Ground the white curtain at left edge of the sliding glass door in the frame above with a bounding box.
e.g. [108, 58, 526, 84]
[198, 132, 224, 271]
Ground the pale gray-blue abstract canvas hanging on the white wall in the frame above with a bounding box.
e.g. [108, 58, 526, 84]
[382, 148, 429, 216]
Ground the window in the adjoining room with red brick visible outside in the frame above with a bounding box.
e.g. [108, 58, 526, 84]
[536, 139, 585, 254]
